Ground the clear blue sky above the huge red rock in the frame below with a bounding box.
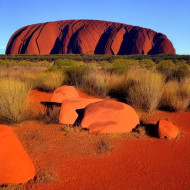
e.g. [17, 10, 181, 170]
[0, 0, 190, 54]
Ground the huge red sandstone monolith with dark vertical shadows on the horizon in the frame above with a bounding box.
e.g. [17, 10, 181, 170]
[6, 20, 175, 55]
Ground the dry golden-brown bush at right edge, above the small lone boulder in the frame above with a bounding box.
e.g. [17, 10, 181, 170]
[160, 78, 190, 111]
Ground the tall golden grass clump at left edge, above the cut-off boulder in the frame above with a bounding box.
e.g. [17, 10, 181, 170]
[0, 79, 31, 123]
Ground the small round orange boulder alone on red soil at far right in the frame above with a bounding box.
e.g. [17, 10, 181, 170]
[158, 120, 179, 139]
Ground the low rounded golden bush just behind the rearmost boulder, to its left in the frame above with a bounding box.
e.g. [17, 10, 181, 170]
[35, 71, 65, 92]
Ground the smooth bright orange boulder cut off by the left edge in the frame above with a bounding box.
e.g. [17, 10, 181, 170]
[0, 125, 35, 184]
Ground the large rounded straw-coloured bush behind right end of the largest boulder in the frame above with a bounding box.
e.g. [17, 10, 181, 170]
[127, 70, 164, 112]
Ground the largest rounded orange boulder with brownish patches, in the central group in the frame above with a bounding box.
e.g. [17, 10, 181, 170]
[81, 100, 139, 133]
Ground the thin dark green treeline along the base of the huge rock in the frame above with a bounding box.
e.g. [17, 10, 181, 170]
[0, 54, 190, 64]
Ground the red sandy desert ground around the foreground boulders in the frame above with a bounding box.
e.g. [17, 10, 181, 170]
[13, 91, 190, 190]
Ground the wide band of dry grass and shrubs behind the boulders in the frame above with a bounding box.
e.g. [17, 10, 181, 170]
[0, 55, 190, 122]
